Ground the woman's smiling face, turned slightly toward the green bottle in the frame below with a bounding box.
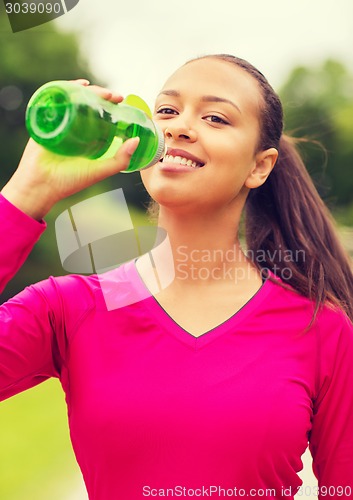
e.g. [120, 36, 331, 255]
[141, 58, 272, 215]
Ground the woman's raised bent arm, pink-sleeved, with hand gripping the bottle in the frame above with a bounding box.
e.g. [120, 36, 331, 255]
[0, 87, 138, 400]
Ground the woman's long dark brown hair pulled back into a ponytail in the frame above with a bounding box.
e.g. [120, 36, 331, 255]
[149, 54, 353, 326]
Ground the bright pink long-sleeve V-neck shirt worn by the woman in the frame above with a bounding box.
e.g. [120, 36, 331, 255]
[0, 193, 353, 500]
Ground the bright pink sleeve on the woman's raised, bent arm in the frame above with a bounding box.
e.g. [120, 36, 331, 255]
[0, 196, 64, 400]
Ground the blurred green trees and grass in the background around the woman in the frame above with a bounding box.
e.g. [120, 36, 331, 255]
[0, 7, 353, 500]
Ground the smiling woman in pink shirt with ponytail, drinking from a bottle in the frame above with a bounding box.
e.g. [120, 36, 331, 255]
[0, 55, 353, 500]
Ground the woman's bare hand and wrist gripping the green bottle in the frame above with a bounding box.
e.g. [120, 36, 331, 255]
[2, 80, 139, 220]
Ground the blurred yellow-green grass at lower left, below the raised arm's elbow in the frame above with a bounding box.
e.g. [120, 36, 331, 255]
[0, 380, 82, 500]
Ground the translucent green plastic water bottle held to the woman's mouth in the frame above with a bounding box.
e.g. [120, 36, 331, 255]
[26, 81, 165, 172]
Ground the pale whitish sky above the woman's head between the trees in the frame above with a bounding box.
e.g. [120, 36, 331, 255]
[55, 0, 353, 106]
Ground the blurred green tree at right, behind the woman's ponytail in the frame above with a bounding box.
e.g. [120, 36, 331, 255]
[279, 59, 353, 209]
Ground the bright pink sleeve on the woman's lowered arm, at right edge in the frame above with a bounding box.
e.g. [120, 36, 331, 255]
[309, 313, 353, 500]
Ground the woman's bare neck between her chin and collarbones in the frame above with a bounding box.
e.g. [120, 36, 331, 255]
[147, 207, 257, 286]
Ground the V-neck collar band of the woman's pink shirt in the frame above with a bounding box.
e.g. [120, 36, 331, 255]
[125, 261, 275, 348]
